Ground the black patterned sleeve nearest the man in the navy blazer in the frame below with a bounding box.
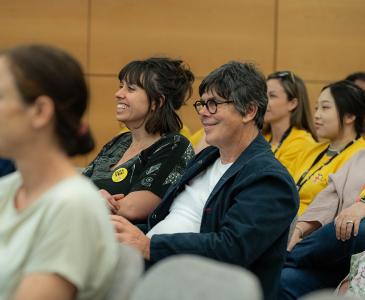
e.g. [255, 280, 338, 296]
[131, 135, 194, 198]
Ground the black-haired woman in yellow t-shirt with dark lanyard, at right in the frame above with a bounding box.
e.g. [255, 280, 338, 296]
[292, 80, 365, 215]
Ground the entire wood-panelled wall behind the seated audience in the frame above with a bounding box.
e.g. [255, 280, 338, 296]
[0, 0, 365, 166]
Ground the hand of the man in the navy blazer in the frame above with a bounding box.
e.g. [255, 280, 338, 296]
[111, 215, 150, 260]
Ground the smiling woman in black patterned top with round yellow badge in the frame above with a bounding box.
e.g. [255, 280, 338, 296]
[84, 58, 194, 223]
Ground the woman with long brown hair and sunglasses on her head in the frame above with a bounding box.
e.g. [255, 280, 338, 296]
[263, 71, 316, 175]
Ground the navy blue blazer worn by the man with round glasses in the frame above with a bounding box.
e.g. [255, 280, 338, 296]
[147, 134, 299, 299]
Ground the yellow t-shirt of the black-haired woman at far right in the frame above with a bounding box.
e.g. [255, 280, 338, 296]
[292, 138, 365, 216]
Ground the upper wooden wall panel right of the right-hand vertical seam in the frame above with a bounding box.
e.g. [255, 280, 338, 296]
[277, 0, 365, 80]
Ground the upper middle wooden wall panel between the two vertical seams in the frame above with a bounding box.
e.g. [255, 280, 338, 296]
[90, 0, 274, 76]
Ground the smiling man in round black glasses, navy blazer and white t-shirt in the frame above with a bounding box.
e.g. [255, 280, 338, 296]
[112, 62, 298, 299]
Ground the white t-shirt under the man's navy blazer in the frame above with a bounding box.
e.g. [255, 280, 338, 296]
[147, 158, 232, 238]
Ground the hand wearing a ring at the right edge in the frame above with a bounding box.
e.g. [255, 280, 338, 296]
[335, 202, 365, 241]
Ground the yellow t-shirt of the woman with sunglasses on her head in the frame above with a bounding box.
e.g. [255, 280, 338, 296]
[265, 127, 317, 176]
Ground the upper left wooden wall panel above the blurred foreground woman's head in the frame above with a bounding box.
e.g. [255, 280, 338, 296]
[0, 0, 88, 68]
